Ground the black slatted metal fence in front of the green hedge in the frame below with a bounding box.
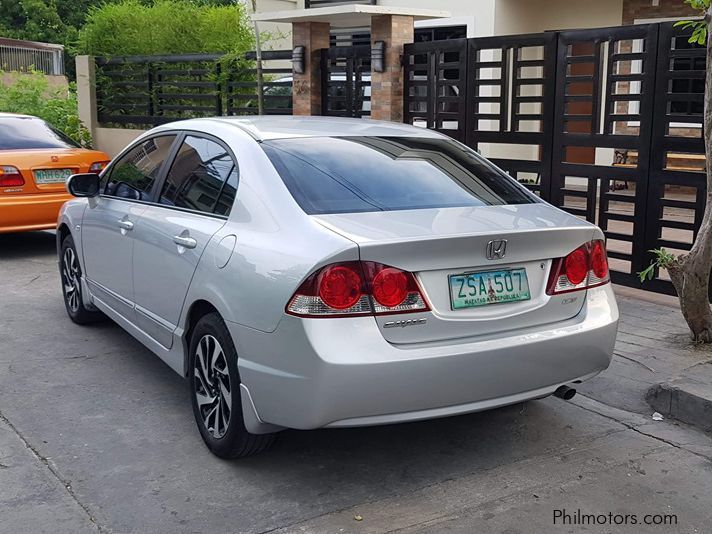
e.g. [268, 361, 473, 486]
[96, 50, 292, 126]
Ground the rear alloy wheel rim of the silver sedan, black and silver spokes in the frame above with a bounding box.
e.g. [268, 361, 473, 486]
[193, 334, 232, 439]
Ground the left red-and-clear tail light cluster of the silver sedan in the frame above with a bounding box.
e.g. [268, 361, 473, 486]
[286, 261, 430, 317]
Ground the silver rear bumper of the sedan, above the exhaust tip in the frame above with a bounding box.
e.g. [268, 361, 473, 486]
[228, 284, 618, 429]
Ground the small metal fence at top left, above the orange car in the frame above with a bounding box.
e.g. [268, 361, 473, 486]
[0, 38, 64, 76]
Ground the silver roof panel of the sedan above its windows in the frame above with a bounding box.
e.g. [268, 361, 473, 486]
[160, 115, 442, 141]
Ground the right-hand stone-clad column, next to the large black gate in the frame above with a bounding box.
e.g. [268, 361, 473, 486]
[371, 15, 414, 122]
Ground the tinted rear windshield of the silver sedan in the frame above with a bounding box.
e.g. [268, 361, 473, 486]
[262, 136, 536, 215]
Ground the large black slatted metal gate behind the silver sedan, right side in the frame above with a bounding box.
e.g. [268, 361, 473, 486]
[404, 23, 705, 293]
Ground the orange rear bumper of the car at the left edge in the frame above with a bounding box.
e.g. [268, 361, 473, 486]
[0, 193, 72, 233]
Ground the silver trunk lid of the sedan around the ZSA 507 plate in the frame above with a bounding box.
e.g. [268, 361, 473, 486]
[314, 203, 594, 343]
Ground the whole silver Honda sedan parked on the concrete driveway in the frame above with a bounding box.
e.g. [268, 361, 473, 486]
[57, 117, 618, 458]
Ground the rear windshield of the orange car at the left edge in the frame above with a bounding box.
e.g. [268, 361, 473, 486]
[0, 117, 79, 150]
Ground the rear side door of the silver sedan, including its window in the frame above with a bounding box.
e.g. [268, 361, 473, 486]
[133, 134, 238, 348]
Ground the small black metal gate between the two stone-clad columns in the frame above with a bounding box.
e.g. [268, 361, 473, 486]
[321, 45, 371, 117]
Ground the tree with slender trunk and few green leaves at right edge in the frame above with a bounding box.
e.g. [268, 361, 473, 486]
[640, 0, 712, 343]
